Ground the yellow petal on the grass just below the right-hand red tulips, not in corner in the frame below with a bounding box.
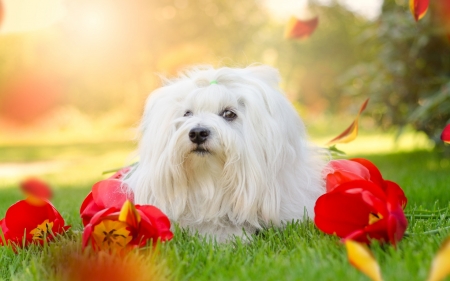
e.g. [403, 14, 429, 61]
[345, 240, 383, 281]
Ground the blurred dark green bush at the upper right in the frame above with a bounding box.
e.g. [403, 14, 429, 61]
[341, 0, 450, 143]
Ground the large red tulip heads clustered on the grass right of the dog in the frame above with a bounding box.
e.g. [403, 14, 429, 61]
[314, 159, 408, 245]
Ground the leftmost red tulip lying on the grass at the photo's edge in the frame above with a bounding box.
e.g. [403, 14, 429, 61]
[0, 199, 70, 246]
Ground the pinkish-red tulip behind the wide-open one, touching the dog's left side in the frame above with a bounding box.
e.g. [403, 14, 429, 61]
[80, 167, 134, 226]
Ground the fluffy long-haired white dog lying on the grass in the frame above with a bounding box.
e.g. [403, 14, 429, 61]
[125, 66, 325, 241]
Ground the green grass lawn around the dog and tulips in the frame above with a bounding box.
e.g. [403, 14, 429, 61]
[0, 137, 450, 281]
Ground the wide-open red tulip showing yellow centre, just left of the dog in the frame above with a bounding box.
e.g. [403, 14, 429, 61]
[83, 200, 173, 252]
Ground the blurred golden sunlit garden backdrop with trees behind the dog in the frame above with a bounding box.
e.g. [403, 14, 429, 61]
[0, 0, 450, 184]
